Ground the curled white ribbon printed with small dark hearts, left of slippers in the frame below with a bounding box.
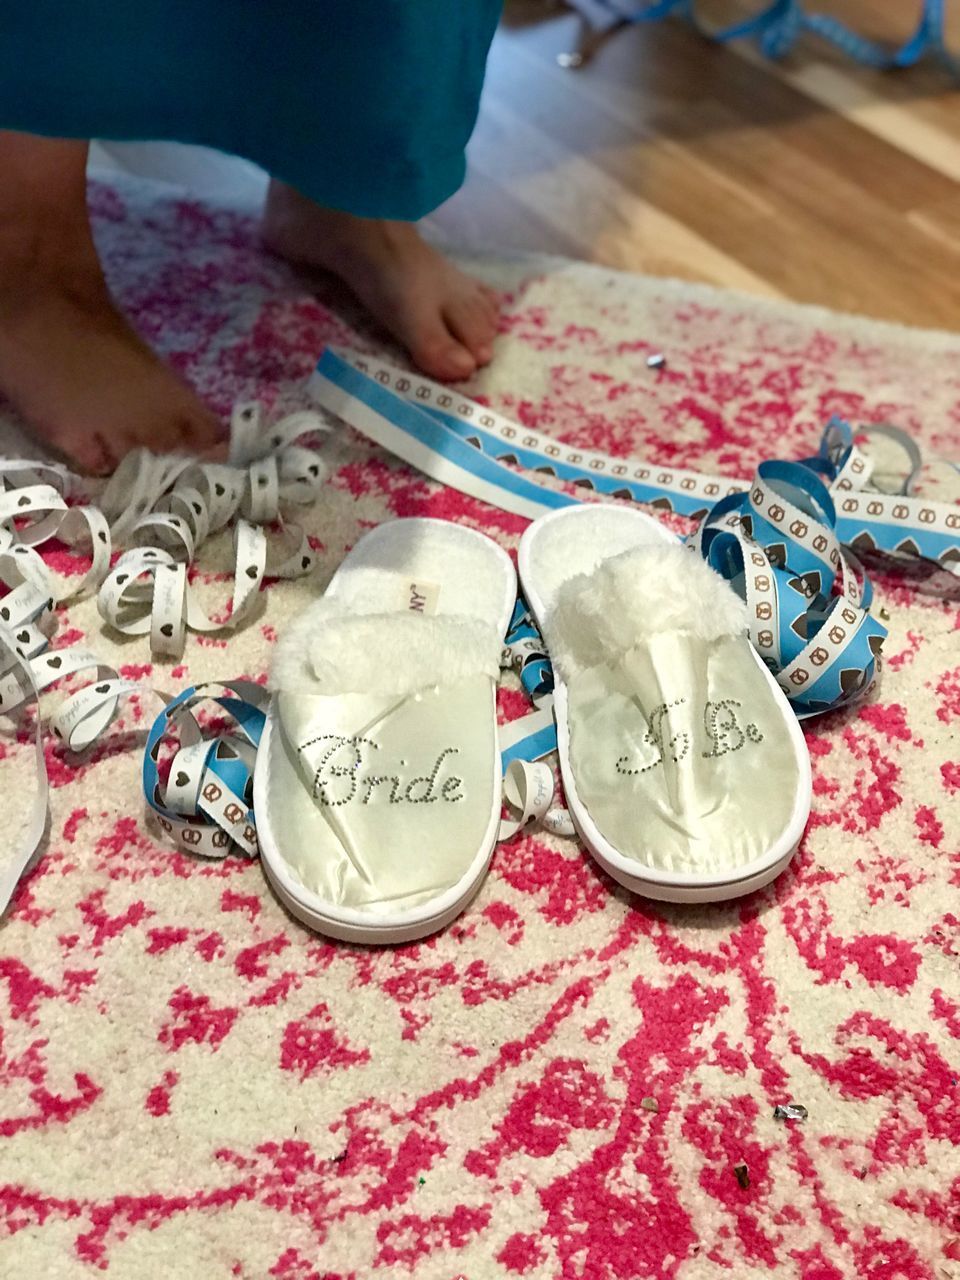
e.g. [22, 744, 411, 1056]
[0, 403, 329, 913]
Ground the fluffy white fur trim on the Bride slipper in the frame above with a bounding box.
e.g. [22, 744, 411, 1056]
[270, 593, 503, 695]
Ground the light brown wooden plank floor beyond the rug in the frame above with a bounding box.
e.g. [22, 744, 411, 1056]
[431, 0, 960, 329]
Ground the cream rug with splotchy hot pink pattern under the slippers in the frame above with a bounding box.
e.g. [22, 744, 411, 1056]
[0, 172, 960, 1280]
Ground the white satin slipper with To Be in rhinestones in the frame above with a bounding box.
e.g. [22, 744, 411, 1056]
[518, 506, 810, 902]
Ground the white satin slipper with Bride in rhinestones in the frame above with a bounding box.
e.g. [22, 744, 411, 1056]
[253, 520, 517, 942]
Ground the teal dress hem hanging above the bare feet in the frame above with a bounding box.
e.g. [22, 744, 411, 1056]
[0, 0, 500, 220]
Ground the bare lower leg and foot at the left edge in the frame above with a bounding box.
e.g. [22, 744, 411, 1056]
[0, 132, 220, 472]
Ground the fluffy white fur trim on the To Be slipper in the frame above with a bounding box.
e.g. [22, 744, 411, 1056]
[547, 545, 748, 678]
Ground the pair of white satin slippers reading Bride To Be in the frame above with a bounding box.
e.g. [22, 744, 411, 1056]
[253, 506, 810, 943]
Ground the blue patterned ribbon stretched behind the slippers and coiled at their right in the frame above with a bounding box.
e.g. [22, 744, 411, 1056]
[311, 349, 960, 717]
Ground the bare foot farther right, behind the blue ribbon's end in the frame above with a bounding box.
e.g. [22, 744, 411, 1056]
[264, 180, 499, 380]
